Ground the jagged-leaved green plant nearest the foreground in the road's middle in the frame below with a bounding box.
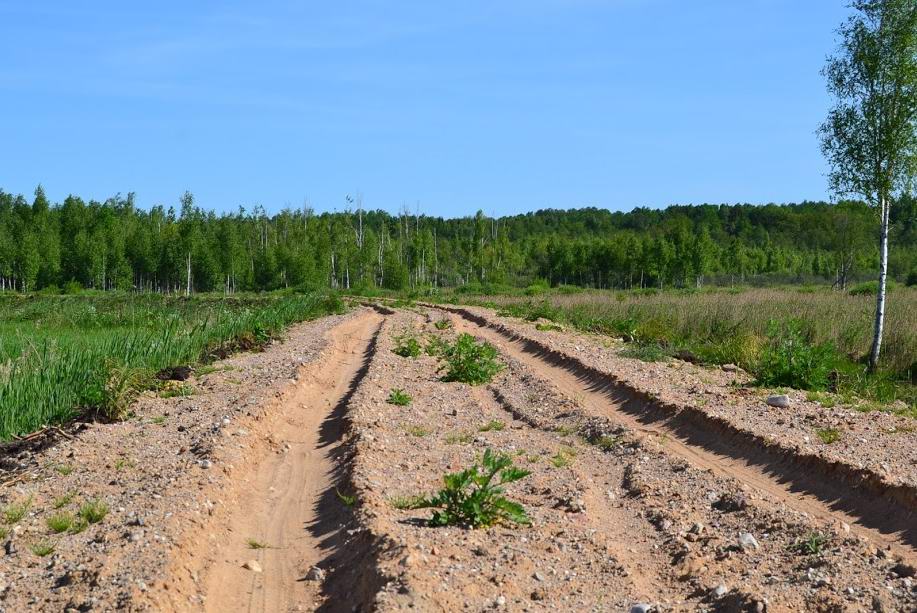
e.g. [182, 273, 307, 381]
[406, 449, 531, 528]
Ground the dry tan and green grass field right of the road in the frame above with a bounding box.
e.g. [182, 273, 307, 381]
[441, 287, 917, 412]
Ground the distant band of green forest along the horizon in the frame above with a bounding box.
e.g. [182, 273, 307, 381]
[0, 187, 917, 293]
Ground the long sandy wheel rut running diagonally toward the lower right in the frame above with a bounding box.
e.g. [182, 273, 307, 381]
[446, 309, 917, 560]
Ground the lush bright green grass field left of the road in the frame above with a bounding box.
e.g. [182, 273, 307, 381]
[0, 293, 342, 440]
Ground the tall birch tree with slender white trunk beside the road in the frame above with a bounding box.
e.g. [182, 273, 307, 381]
[820, 0, 917, 371]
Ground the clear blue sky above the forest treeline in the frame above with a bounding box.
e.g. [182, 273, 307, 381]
[0, 0, 848, 215]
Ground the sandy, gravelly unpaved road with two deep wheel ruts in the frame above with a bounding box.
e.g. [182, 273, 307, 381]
[0, 307, 917, 611]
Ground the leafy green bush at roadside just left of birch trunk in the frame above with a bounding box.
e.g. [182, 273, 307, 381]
[755, 321, 838, 390]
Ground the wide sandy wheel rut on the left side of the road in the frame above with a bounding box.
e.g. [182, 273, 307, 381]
[202, 314, 382, 612]
